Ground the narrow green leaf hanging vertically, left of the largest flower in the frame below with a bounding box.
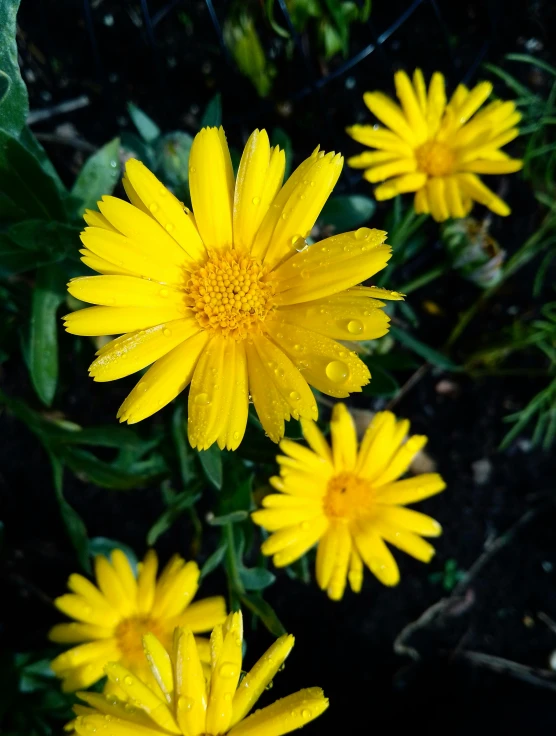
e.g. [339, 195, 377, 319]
[29, 265, 66, 406]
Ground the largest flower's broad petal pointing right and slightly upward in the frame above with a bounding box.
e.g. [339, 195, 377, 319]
[274, 228, 391, 305]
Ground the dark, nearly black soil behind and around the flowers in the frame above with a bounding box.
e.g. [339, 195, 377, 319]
[0, 0, 556, 734]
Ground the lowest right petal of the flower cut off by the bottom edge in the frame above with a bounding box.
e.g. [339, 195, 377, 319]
[230, 687, 328, 736]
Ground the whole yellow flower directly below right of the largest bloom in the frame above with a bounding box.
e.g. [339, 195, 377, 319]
[252, 404, 445, 600]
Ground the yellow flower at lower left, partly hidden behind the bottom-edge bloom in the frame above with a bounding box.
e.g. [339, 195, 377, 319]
[49, 549, 226, 692]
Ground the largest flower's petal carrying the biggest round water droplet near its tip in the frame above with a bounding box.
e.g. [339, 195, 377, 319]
[267, 323, 370, 400]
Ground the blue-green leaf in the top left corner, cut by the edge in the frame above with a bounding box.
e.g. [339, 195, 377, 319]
[0, 0, 29, 136]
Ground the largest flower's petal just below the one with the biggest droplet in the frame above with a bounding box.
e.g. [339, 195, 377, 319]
[253, 334, 318, 419]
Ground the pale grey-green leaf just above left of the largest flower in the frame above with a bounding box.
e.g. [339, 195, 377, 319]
[71, 138, 121, 217]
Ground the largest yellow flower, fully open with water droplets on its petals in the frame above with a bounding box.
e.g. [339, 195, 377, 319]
[65, 128, 401, 449]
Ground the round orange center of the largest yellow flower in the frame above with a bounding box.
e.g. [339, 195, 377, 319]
[187, 251, 274, 340]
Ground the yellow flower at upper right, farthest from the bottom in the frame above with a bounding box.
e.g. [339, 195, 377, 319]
[347, 69, 523, 222]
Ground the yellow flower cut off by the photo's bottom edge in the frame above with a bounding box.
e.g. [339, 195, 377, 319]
[72, 613, 328, 736]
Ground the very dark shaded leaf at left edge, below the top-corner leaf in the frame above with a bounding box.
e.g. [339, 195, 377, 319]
[0, 131, 66, 220]
